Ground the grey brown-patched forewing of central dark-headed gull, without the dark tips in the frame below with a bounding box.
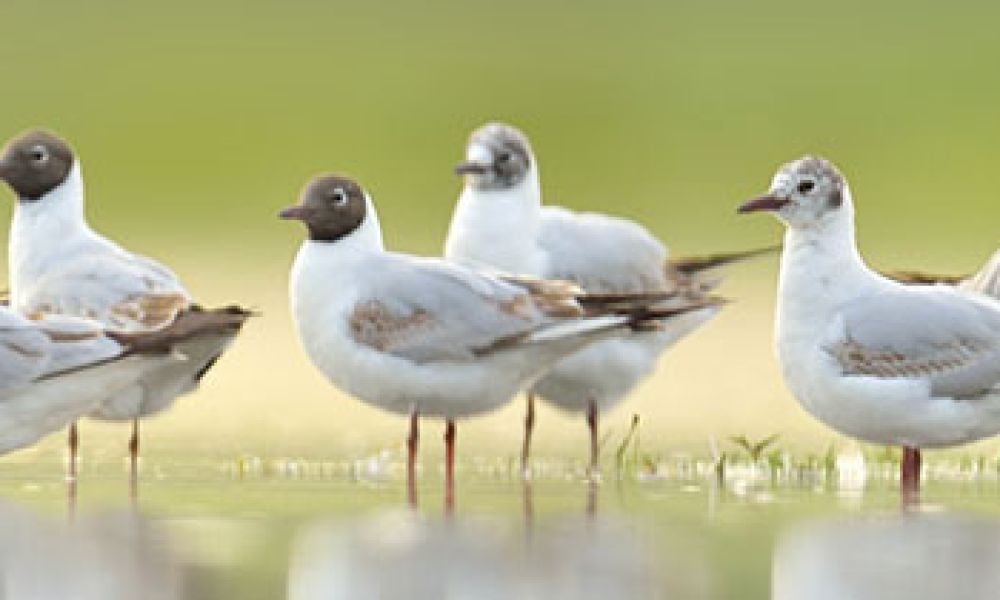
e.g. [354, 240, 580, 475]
[350, 255, 545, 362]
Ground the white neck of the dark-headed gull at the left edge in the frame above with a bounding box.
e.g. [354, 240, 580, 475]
[8, 162, 95, 304]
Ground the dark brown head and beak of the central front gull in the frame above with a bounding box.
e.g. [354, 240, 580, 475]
[278, 175, 368, 242]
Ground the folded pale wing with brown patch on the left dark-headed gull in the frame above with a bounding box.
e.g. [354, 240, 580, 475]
[15, 251, 190, 331]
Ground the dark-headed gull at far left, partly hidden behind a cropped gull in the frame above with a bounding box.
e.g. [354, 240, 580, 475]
[0, 130, 249, 481]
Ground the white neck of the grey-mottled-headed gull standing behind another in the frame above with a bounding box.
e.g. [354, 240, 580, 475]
[445, 165, 543, 275]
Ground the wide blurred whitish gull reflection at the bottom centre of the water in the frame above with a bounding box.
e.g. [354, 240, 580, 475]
[288, 512, 710, 600]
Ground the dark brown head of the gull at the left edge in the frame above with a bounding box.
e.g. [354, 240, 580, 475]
[0, 129, 76, 202]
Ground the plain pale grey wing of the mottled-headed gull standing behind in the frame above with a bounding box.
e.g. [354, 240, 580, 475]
[538, 206, 671, 293]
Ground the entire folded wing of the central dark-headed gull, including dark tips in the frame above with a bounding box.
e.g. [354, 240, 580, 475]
[349, 254, 704, 362]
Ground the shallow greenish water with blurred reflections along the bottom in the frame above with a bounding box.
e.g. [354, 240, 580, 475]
[0, 461, 1000, 599]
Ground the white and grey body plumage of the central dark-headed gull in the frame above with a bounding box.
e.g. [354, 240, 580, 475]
[291, 196, 688, 419]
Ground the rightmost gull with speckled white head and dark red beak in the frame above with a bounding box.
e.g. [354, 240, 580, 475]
[739, 157, 1000, 502]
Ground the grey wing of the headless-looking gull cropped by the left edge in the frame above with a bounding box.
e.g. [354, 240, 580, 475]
[0, 308, 51, 392]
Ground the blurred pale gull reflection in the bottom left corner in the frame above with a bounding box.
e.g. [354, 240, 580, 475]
[0, 504, 188, 600]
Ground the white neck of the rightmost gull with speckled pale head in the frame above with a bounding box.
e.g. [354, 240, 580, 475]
[777, 197, 881, 343]
